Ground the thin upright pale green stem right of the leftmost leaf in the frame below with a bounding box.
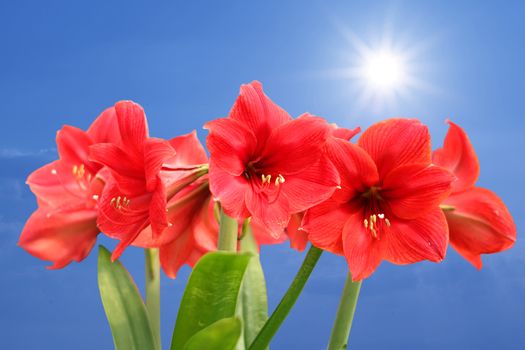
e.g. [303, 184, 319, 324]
[144, 248, 162, 350]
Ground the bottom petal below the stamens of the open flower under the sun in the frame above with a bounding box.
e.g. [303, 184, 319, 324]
[343, 212, 385, 281]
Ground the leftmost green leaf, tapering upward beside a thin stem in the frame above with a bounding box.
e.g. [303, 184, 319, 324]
[98, 246, 156, 350]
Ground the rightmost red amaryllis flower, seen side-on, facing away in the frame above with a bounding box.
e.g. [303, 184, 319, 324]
[433, 121, 516, 269]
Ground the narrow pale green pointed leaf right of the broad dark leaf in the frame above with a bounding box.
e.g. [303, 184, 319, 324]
[240, 223, 268, 349]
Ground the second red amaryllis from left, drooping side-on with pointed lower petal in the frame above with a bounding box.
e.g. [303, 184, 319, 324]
[90, 101, 207, 259]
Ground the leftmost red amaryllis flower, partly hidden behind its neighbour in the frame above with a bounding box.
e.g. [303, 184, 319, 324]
[18, 108, 119, 269]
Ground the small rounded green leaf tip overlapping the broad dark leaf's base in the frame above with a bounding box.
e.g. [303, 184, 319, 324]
[183, 317, 242, 350]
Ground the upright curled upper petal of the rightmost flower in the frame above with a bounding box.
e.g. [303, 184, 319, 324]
[432, 120, 479, 192]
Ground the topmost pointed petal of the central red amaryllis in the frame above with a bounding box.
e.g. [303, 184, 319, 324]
[229, 81, 292, 146]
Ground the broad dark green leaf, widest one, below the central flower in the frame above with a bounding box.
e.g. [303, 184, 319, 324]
[171, 252, 252, 350]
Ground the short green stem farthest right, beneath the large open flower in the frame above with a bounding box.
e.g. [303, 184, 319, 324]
[328, 273, 361, 350]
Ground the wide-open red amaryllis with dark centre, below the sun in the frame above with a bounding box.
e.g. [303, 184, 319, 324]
[303, 119, 454, 281]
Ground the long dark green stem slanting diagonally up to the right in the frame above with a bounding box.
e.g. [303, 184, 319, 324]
[249, 246, 323, 350]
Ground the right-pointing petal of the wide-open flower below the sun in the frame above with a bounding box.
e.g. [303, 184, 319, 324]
[381, 164, 455, 219]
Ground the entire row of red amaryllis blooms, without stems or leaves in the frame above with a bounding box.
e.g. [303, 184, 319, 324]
[19, 82, 516, 280]
